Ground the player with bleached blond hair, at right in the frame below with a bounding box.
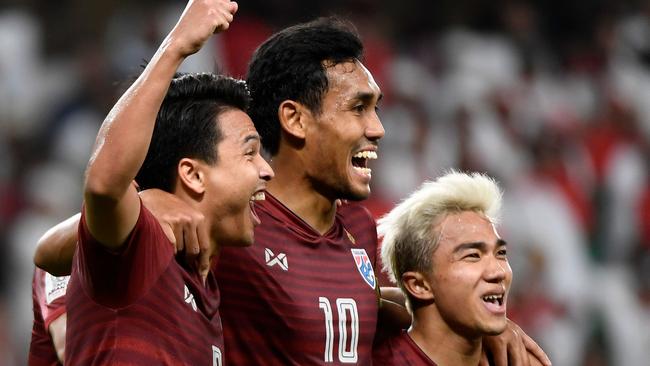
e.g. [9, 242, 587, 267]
[373, 172, 536, 366]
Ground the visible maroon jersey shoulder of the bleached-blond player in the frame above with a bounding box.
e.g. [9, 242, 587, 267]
[372, 331, 436, 366]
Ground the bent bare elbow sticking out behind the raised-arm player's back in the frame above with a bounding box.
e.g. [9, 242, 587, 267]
[34, 214, 81, 276]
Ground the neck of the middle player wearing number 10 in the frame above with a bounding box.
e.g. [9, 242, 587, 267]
[267, 154, 336, 234]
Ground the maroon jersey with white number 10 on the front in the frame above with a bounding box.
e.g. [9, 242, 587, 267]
[217, 193, 378, 365]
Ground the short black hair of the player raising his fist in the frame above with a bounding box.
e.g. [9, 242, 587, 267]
[135, 73, 250, 192]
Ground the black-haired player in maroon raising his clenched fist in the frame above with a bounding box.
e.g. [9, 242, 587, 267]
[60, 0, 273, 365]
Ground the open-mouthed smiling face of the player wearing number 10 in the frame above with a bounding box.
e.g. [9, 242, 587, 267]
[305, 61, 384, 200]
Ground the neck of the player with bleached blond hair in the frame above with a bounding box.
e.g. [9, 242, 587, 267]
[408, 304, 481, 366]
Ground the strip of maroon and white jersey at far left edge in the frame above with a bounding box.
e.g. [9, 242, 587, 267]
[28, 268, 70, 366]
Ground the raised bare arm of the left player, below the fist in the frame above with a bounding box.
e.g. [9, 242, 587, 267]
[84, 45, 184, 248]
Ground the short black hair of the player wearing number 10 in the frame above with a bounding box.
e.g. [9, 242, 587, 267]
[247, 17, 363, 155]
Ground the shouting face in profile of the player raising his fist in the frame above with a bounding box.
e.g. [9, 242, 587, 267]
[203, 109, 273, 246]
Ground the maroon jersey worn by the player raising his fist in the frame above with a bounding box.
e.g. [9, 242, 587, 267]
[66, 205, 224, 365]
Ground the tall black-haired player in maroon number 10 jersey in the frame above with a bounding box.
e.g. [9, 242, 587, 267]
[34, 14, 548, 365]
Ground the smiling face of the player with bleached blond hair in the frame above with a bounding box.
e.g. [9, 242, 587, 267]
[430, 211, 512, 337]
